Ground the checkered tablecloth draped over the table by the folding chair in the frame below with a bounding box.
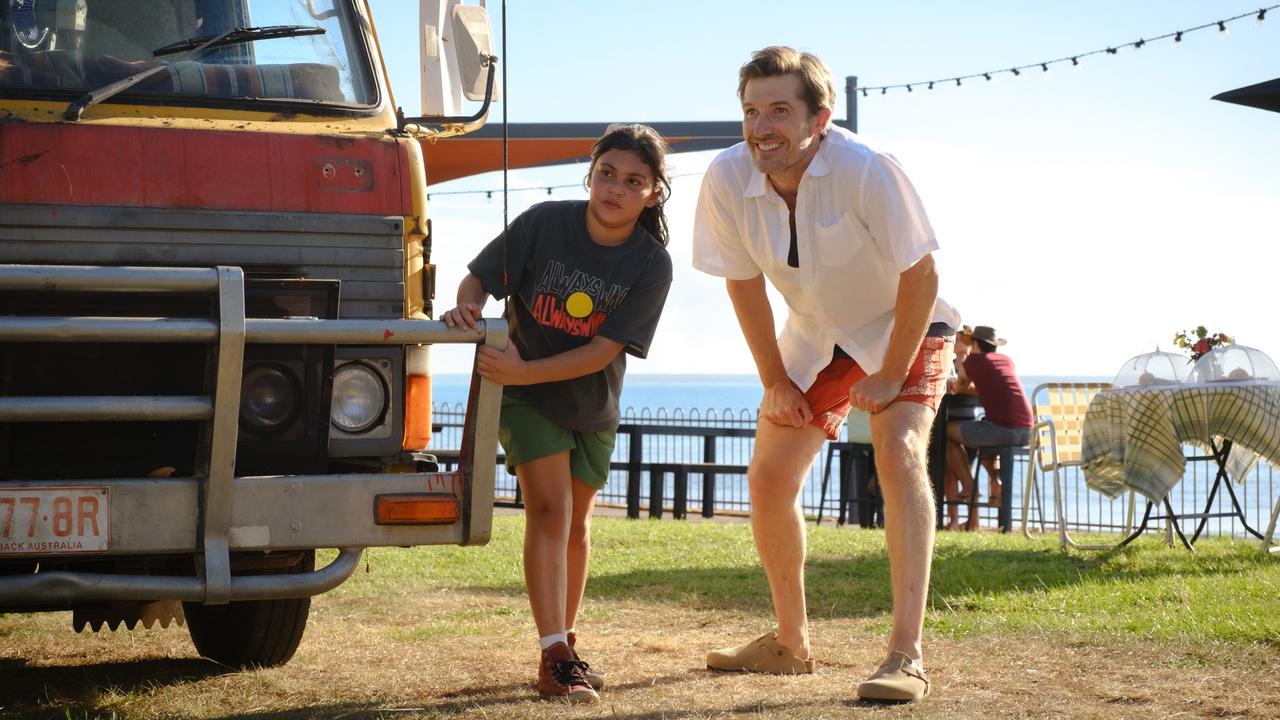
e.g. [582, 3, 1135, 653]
[1082, 382, 1280, 502]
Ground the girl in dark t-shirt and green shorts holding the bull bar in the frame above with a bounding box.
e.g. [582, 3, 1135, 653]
[443, 124, 671, 702]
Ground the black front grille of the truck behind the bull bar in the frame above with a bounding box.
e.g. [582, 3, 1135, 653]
[0, 281, 338, 480]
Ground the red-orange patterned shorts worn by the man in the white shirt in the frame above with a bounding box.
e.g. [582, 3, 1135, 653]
[804, 336, 952, 439]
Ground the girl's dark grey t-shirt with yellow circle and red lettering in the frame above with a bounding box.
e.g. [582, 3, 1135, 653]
[467, 200, 671, 432]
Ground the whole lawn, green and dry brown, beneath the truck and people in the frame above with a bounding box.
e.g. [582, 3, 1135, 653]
[0, 515, 1280, 720]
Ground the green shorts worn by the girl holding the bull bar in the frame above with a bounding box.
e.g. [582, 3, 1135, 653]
[498, 395, 618, 489]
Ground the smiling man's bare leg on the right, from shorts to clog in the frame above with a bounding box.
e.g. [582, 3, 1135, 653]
[872, 401, 936, 661]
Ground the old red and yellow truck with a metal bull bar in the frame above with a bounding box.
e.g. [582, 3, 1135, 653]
[0, 0, 507, 666]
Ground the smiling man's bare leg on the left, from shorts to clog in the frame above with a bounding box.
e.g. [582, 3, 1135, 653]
[746, 419, 827, 660]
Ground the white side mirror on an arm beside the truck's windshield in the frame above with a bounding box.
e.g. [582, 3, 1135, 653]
[419, 0, 499, 117]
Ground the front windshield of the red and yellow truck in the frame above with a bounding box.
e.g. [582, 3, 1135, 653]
[0, 0, 378, 108]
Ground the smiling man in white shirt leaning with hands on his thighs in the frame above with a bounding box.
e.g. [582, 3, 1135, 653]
[694, 47, 960, 701]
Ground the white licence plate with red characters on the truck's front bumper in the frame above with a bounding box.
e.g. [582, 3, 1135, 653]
[0, 487, 111, 555]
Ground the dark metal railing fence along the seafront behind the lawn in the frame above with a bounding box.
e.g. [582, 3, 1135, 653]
[431, 404, 1280, 538]
